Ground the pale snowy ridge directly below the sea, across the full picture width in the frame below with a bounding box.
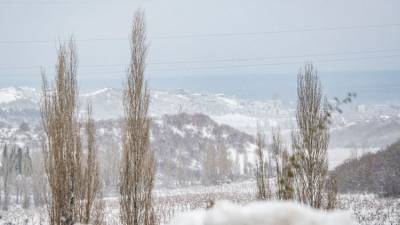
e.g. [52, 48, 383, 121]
[0, 87, 400, 137]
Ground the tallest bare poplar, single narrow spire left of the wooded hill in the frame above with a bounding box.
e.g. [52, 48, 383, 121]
[120, 11, 155, 225]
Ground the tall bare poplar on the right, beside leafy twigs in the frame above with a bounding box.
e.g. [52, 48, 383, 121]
[292, 64, 330, 208]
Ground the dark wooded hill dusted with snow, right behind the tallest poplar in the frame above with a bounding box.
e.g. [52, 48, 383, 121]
[87, 113, 255, 186]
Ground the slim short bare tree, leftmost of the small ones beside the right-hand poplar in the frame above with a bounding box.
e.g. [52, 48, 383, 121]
[255, 128, 271, 200]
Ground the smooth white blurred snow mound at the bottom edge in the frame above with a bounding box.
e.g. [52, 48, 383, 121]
[170, 201, 356, 225]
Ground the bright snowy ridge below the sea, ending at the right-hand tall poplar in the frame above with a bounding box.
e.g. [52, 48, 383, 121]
[0, 88, 293, 133]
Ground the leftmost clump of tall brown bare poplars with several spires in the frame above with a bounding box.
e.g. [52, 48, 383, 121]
[41, 40, 100, 225]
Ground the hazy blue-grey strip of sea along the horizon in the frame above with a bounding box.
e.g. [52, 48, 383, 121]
[0, 71, 400, 105]
